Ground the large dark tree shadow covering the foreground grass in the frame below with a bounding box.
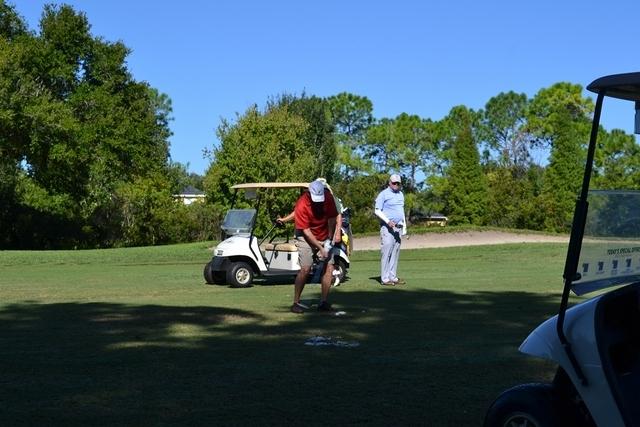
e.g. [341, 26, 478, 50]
[0, 288, 558, 426]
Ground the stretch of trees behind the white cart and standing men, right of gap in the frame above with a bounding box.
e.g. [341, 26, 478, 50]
[204, 82, 640, 237]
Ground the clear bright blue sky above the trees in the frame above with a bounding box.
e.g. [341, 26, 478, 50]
[15, 0, 640, 174]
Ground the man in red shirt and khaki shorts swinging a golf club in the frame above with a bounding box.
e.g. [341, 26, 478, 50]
[291, 180, 341, 313]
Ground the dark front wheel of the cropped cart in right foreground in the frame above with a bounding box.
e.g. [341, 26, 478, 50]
[484, 383, 562, 427]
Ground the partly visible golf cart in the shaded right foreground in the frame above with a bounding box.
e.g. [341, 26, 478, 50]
[485, 73, 640, 427]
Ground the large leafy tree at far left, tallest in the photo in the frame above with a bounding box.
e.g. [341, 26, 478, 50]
[0, 2, 171, 247]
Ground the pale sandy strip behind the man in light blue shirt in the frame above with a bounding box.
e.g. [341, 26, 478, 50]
[353, 231, 569, 251]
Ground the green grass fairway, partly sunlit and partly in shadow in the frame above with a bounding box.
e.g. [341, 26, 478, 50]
[0, 243, 584, 426]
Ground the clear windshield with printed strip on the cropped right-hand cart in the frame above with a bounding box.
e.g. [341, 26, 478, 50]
[572, 190, 640, 295]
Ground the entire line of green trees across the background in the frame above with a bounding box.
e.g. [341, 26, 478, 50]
[0, 0, 640, 249]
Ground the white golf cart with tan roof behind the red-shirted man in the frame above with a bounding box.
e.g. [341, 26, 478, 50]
[204, 182, 349, 288]
